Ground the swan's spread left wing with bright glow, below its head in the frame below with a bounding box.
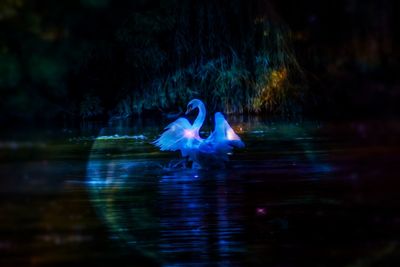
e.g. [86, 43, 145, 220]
[153, 118, 197, 157]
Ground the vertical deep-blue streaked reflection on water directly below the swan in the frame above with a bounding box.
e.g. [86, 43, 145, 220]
[159, 170, 244, 263]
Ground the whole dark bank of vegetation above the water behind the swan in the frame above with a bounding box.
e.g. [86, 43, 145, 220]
[0, 0, 400, 122]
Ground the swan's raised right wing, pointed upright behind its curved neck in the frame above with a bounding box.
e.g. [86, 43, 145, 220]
[206, 112, 244, 153]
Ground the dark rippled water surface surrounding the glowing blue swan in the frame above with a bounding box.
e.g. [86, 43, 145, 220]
[0, 119, 400, 267]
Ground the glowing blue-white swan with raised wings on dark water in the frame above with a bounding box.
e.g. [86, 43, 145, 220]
[153, 99, 244, 168]
